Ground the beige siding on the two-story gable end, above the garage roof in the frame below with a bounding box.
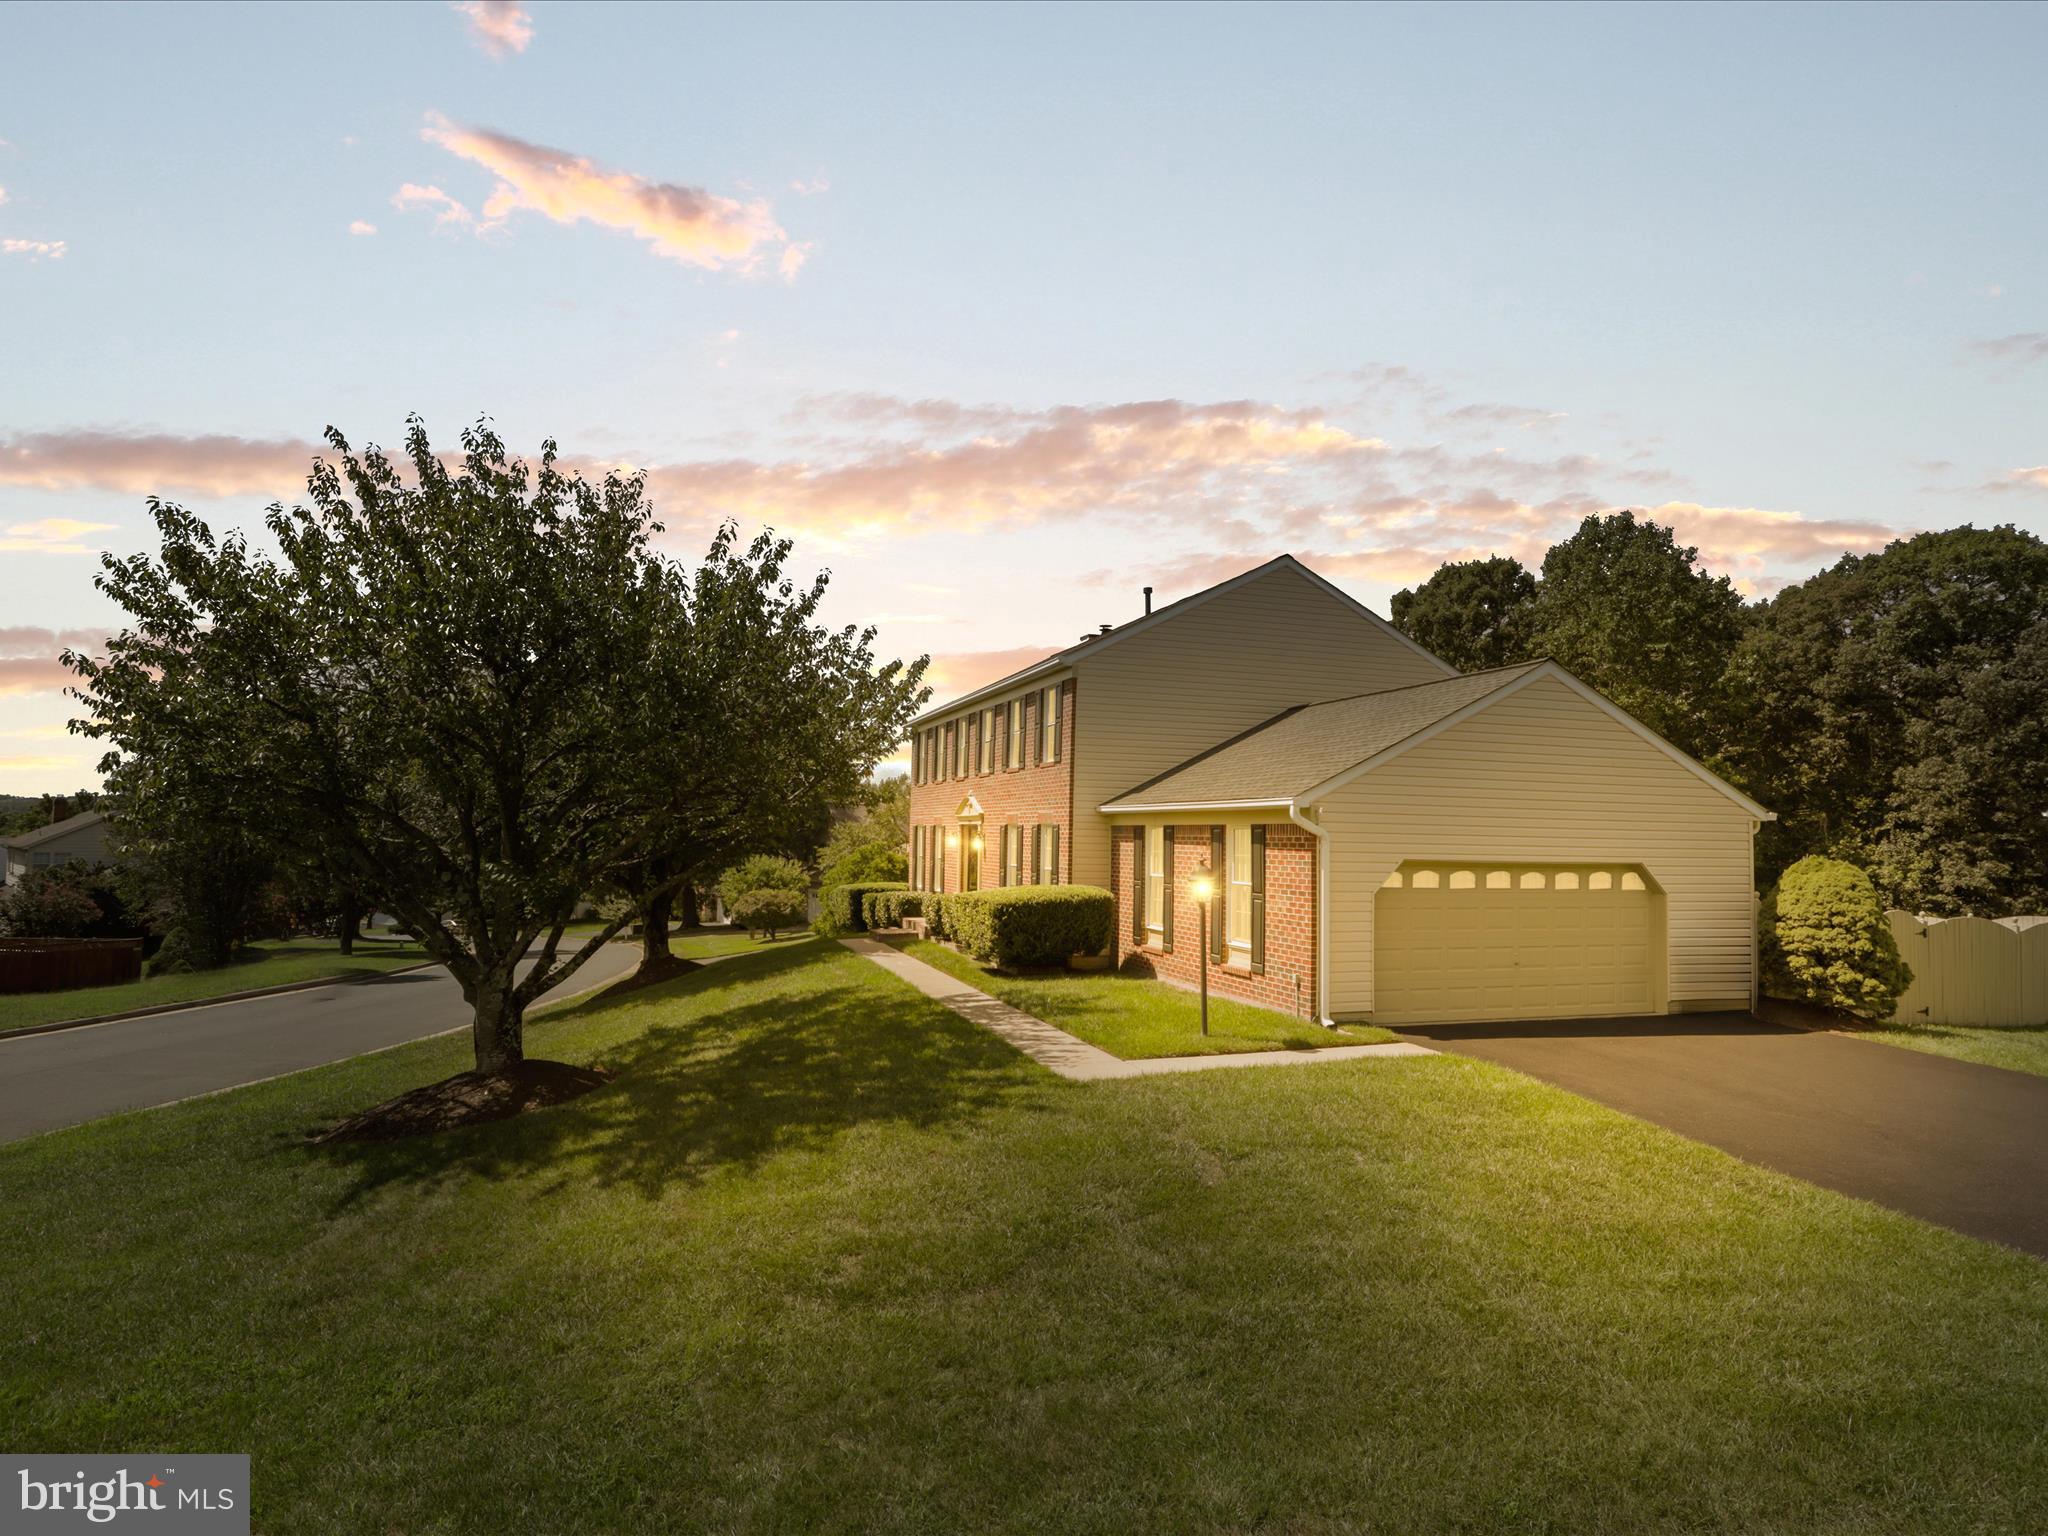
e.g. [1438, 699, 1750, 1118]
[1069, 567, 1452, 885]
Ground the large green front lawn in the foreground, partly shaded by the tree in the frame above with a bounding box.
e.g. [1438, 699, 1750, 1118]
[0, 942, 2048, 1536]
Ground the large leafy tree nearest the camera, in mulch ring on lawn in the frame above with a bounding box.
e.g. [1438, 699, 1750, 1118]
[70, 422, 925, 1071]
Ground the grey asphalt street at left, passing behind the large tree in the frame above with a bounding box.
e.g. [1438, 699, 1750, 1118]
[0, 944, 639, 1141]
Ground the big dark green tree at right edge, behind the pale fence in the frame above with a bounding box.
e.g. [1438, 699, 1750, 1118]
[1718, 526, 2048, 913]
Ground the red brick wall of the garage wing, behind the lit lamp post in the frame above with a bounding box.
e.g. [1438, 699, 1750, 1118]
[1110, 821, 1317, 1018]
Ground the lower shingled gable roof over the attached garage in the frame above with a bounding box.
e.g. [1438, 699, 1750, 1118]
[1100, 659, 1778, 821]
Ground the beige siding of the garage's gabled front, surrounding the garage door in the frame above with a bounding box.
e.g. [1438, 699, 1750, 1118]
[1311, 680, 1753, 1018]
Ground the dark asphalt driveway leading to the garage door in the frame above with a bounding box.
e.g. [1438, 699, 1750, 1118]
[1403, 1014, 2048, 1257]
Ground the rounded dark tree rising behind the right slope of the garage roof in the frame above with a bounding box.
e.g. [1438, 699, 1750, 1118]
[1526, 512, 1745, 756]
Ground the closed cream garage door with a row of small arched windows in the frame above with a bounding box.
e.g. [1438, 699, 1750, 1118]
[1372, 864, 1661, 1024]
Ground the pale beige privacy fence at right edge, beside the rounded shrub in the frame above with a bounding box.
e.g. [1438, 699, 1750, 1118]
[1884, 911, 2048, 1026]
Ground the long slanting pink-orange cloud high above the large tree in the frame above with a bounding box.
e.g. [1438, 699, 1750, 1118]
[420, 113, 809, 276]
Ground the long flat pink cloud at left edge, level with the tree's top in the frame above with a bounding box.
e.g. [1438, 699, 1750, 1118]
[0, 428, 322, 499]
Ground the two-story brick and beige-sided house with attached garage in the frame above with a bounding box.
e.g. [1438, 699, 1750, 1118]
[909, 555, 1772, 1024]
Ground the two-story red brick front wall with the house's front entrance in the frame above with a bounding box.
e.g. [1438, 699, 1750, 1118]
[907, 678, 1075, 891]
